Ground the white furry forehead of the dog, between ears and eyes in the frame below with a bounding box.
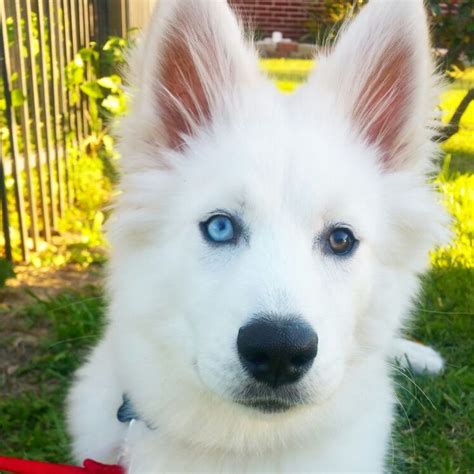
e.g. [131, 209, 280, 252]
[179, 96, 378, 226]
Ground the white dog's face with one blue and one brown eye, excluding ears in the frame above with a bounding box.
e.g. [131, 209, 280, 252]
[152, 115, 382, 411]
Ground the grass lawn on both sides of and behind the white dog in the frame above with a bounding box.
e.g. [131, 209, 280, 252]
[0, 63, 474, 473]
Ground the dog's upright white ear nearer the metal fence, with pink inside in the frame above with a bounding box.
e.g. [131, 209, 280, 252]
[137, 0, 258, 149]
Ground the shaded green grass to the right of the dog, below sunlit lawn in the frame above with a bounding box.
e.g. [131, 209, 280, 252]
[395, 267, 474, 474]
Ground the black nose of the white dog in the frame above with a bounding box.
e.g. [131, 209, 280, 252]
[237, 316, 318, 388]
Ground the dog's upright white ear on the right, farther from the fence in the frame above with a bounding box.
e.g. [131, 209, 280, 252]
[313, 0, 436, 169]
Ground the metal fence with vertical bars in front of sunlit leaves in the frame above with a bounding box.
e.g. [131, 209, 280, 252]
[0, 0, 153, 261]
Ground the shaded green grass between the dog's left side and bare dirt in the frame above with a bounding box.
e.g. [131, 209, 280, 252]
[0, 288, 104, 462]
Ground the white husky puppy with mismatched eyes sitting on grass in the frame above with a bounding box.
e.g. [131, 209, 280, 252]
[68, 0, 445, 473]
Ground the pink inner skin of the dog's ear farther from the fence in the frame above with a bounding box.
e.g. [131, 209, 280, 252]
[353, 44, 414, 162]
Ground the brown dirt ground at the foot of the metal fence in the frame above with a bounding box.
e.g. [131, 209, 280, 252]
[0, 265, 102, 395]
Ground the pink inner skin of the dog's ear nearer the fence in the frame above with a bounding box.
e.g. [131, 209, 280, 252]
[158, 19, 212, 149]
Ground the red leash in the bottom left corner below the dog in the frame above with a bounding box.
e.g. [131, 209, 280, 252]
[0, 456, 125, 474]
